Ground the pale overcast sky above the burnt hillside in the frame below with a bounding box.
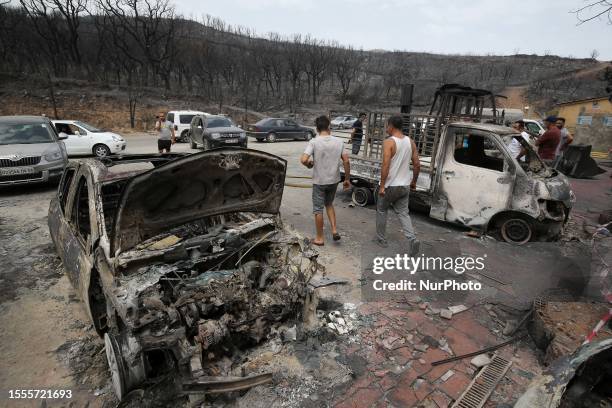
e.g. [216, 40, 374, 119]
[174, 0, 612, 60]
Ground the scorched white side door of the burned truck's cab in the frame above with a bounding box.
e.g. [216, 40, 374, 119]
[430, 126, 515, 227]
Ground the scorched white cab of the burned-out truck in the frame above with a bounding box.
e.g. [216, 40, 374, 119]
[426, 122, 575, 244]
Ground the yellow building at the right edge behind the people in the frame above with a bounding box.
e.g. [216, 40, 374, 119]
[556, 97, 612, 130]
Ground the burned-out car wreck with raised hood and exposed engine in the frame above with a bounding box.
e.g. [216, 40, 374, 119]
[49, 148, 323, 400]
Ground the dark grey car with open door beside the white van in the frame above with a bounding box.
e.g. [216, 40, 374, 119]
[189, 114, 247, 150]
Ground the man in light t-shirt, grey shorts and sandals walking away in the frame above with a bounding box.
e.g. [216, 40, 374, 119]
[300, 116, 351, 246]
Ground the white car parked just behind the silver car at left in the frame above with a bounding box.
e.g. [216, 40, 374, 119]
[52, 120, 126, 157]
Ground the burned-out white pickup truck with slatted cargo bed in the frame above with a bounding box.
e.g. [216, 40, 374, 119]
[350, 87, 575, 244]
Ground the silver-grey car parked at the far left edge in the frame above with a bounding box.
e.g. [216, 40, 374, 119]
[0, 116, 68, 185]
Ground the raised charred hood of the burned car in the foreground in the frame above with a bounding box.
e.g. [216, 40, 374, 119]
[112, 148, 287, 255]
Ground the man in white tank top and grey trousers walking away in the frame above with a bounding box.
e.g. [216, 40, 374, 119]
[376, 116, 421, 256]
